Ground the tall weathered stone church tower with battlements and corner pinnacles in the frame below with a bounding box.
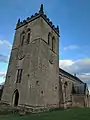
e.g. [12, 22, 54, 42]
[2, 5, 59, 108]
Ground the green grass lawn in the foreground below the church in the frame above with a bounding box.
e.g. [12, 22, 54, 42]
[0, 108, 90, 120]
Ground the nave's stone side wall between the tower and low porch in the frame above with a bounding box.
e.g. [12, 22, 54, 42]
[59, 76, 79, 108]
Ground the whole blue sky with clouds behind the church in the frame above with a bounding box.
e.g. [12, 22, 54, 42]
[0, 0, 90, 89]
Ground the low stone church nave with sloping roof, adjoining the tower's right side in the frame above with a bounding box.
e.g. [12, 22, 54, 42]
[59, 69, 89, 108]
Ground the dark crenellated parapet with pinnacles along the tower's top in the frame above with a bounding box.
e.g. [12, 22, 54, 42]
[16, 4, 59, 35]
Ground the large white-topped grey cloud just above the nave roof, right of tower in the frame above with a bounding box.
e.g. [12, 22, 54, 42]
[59, 58, 90, 74]
